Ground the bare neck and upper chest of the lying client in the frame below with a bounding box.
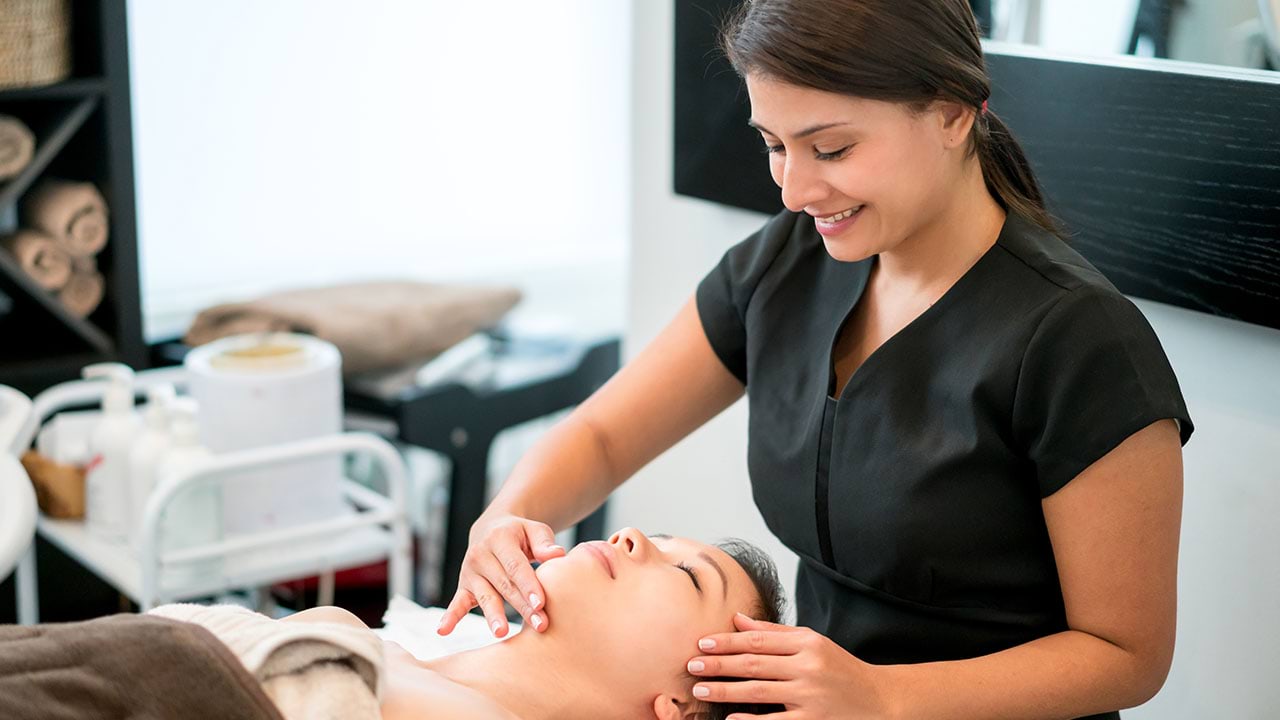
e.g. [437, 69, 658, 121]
[425, 622, 635, 720]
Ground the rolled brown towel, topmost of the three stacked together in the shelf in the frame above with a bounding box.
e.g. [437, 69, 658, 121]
[23, 179, 108, 258]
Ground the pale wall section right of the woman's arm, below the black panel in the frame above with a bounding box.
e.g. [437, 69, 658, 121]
[1125, 301, 1280, 720]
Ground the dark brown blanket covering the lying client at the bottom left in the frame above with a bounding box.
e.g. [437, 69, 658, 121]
[0, 615, 282, 720]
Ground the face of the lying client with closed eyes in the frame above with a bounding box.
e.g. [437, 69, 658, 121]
[538, 528, 758, 700]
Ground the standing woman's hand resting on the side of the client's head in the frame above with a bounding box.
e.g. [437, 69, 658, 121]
[689, 614, 888, 720]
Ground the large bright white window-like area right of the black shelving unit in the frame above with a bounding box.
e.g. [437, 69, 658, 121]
[129, 0, 630, 337]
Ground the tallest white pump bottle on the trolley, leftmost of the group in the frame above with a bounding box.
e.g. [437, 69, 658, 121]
[83, 363, 141, 541]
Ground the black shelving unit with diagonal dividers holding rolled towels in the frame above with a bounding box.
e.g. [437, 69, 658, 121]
[0, 0, 148, 395]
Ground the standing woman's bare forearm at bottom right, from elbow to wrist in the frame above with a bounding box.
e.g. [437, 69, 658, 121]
[884, 630, 1167, 720]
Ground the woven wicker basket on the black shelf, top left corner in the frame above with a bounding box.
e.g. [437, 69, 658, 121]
[0, 0, 72, 88]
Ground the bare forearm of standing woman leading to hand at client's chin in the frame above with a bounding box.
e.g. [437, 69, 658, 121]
[485, 413, 621, 532]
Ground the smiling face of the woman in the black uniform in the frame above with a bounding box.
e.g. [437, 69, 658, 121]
[746, 74, 966, 261]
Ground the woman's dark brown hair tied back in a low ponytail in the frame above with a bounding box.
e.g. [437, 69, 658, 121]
[719, 0, 1062, 237]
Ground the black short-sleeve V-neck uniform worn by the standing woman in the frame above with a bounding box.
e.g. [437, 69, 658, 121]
[696, 207, 1193, 717]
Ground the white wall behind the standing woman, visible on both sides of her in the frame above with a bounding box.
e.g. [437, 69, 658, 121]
[611, 0, 1280, 720]
